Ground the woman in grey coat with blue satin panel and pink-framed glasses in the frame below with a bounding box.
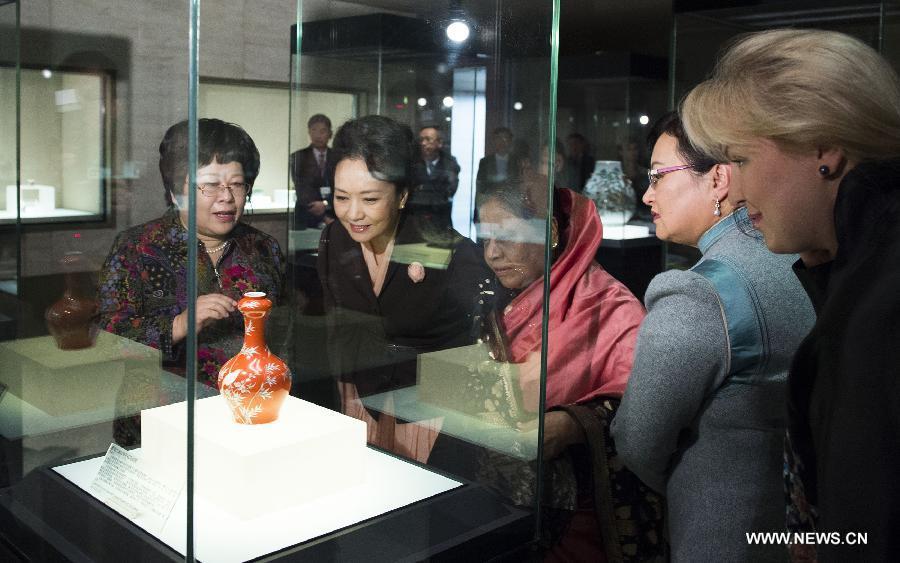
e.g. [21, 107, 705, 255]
[612, 114, 814, 562]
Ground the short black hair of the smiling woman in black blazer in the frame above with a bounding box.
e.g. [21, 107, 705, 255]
[334, 115, 418, 192]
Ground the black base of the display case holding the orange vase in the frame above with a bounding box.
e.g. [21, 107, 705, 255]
[0, 462, 534, 563]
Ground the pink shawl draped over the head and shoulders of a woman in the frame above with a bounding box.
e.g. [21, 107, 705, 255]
[503, 189, 645, 410]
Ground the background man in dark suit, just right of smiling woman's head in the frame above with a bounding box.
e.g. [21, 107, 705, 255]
[407, 125, 459, 235]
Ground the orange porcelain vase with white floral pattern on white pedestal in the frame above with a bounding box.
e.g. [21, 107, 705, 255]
[218, 291, 291, 424]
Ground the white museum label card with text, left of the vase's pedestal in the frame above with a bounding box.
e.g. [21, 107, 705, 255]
[90, 444, 181, 531]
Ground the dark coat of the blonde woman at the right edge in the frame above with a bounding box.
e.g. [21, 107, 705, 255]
[788, 156, 900, 562]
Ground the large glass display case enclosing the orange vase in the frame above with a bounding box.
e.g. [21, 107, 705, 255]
[0, 0, 568, 561]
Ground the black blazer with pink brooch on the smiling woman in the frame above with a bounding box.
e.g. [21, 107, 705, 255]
[317, 215, 493, 397]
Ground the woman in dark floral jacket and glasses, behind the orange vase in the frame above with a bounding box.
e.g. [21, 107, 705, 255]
[99, 119, 284, 387]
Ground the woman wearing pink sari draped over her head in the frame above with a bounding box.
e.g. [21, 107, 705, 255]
[479, 187, 664, 561]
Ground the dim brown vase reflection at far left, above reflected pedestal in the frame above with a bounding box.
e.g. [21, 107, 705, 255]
[44, 252, 97, 350]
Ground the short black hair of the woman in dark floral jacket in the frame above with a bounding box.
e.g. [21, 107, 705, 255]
[159, 118, 259, 205]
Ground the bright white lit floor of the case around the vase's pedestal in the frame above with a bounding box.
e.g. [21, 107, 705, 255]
[54, 448, 461, 563]
